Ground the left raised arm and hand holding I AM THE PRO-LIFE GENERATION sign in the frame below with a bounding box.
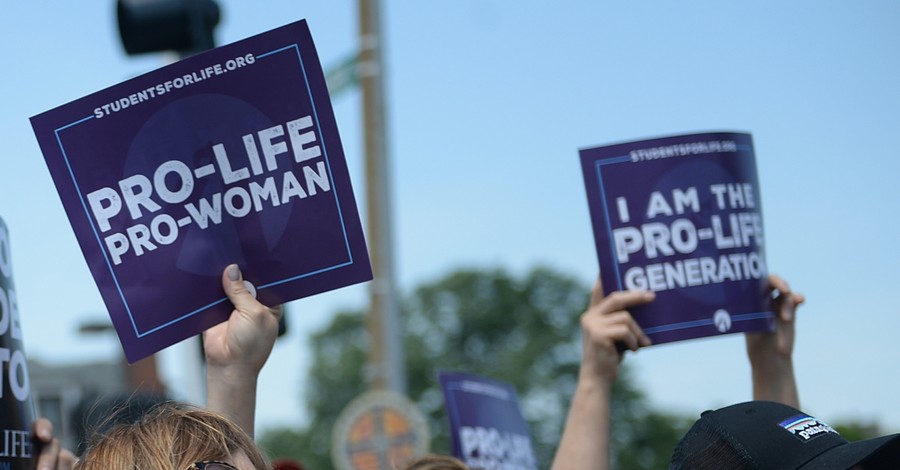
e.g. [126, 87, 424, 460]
[552, 280, 655, 470]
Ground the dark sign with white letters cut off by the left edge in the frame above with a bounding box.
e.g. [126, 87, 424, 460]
[0, 218, 36, 470]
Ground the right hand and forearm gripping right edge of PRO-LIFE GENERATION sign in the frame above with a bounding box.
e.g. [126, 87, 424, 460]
[746, 274, 806, 408]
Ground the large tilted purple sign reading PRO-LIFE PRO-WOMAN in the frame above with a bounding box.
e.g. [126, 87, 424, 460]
[31, 21, 372, 362]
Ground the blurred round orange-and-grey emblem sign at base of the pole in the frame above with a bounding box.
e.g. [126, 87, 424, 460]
[331, 390, 429, 470]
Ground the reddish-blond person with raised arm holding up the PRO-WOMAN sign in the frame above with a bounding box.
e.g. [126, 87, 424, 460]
[54, 265, 283, 470]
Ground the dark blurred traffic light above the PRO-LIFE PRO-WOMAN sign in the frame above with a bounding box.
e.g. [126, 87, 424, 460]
[116, 0, 219, 56]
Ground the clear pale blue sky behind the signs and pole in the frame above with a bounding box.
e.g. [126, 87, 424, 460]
[0, 0, 900, 438]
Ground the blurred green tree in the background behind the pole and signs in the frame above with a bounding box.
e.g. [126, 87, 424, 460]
[263, 268, 686, 469]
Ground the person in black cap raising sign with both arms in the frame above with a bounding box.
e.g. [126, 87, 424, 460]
[552, 275, 900, 470]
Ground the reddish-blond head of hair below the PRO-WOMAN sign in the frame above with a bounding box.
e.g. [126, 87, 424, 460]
[75, 402, 269, 470]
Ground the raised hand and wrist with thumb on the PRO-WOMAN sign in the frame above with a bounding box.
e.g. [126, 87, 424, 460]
[203, 264, 283, 437]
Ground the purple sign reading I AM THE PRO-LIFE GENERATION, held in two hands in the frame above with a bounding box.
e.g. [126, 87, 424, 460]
[580, 133, 774, 343]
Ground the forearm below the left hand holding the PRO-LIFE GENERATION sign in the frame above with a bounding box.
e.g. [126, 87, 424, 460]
[552, 378, 612, 470]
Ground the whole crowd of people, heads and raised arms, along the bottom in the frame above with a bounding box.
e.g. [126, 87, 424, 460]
[24, 265, 900, 470]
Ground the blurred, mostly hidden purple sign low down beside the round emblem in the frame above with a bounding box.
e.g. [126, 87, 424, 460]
[439, 373, 537, 470]
